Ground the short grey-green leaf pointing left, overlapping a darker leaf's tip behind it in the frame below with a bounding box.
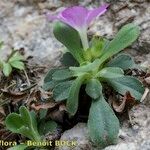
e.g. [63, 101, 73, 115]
[52, 69, 73, 81]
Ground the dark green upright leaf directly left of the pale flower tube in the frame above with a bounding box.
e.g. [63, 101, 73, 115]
[53, 22, 84, 63]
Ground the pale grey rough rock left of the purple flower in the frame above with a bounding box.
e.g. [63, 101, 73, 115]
[0, 0, 61, 66]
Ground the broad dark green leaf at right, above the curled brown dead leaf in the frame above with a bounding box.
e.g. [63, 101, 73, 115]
[107, 76, 144, 100]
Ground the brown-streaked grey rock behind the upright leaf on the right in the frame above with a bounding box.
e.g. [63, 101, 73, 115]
[90, 0, 150, 54]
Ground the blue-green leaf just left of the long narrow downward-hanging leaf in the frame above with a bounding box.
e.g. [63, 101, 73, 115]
[53, 81, 73, 102]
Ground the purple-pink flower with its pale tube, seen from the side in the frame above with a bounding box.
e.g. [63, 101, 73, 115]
[47, 4, 108, 49]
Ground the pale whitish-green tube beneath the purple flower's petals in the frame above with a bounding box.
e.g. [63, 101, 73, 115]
[79, 29, 89, 50]
